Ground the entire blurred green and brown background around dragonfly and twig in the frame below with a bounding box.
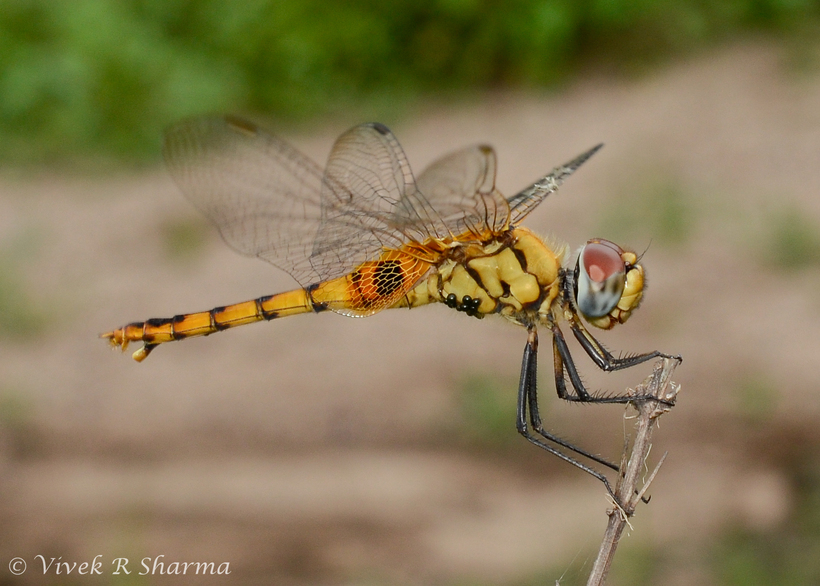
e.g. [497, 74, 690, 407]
[0, 0, 820, 586]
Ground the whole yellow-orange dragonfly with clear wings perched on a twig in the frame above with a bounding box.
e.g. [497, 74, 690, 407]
[101, 116, 671, 494]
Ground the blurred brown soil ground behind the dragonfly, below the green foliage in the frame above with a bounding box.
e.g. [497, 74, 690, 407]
[0, 40, 820, 586]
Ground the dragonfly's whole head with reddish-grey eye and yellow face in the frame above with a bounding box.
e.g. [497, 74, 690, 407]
[573, 238, 644, 330]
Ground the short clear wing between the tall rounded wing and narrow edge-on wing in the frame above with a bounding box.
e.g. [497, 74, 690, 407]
[416, 145, 509, 236]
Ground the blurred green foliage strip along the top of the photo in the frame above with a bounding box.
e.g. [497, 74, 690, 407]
[0, 0, 820, 163]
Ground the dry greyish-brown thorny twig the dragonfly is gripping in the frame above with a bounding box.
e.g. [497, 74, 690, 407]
[587, 358, 680, 586]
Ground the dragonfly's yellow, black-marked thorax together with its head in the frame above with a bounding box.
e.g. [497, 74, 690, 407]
[395, 227, 644, 330]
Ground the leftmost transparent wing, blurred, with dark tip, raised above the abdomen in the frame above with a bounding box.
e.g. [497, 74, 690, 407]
[163, 117, 322, 286]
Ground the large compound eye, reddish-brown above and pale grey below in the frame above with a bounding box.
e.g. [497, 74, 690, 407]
[575, 239, 626, 318]
